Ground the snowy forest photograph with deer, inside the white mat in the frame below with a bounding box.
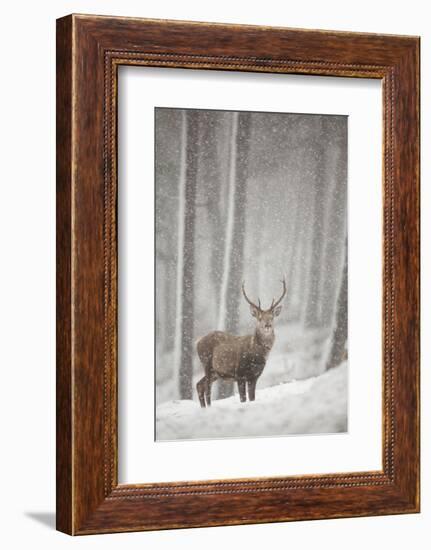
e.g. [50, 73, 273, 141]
[154, 107, 348, 441]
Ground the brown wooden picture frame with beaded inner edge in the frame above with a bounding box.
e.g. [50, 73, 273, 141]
[57, 15, 419, 534]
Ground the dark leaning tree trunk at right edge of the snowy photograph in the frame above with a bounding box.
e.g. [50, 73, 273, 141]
[326, 241, 348, 369]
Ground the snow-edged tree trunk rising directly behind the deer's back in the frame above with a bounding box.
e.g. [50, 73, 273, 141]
[217, 113, 251, 399]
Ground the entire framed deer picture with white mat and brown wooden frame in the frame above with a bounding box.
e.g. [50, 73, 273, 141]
[57, 15, 419, 535]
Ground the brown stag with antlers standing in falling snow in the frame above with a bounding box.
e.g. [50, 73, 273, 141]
[196, 279, 286, 407]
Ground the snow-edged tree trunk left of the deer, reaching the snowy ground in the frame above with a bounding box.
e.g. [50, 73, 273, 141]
[175, 111, 199, 399]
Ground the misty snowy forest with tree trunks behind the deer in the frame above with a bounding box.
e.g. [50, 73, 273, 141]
[155, 108, 348, 405]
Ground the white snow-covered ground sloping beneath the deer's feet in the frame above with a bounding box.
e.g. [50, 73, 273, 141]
[156, 363, 347, 440]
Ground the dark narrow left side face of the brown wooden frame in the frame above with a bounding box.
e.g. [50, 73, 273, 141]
[56, 19, 73, 533]
